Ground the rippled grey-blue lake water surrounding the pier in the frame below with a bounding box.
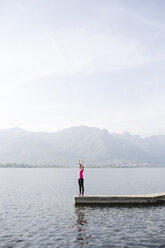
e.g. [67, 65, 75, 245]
[0, 168, 165, 248]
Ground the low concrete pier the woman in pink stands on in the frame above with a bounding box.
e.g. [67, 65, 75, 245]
[74, 193, 165, 206]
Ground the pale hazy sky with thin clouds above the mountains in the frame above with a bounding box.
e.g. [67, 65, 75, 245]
[0, 0, 165, 136]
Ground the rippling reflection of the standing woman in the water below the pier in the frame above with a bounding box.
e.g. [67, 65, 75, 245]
[73, 207, 91, 247]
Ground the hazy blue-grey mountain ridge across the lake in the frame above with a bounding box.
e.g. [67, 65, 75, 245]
[0, 126, 165, 165]
